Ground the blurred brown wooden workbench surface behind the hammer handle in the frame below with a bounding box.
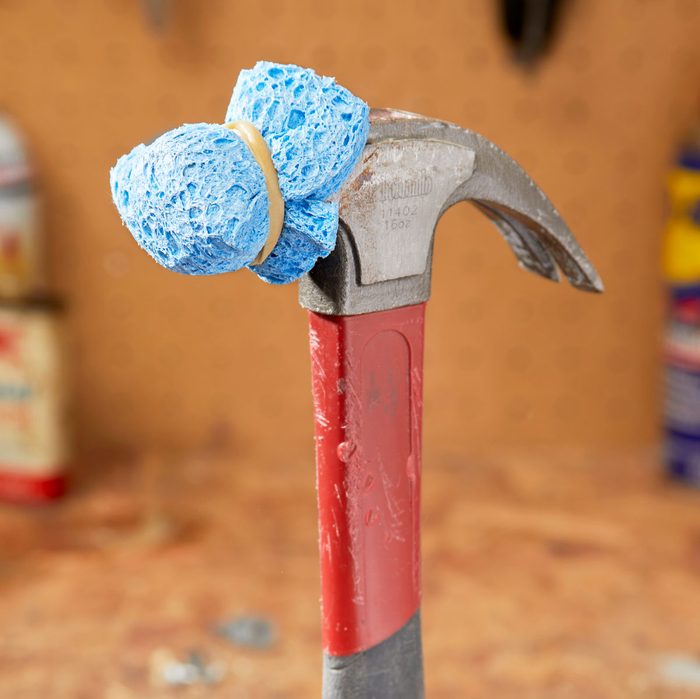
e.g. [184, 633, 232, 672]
[0, 451, 700, 699]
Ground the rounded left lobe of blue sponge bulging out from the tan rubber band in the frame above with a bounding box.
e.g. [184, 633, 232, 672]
[110, 124, 268, 274]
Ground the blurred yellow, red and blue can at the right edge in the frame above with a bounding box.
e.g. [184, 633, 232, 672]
[662, 124, 700, 486]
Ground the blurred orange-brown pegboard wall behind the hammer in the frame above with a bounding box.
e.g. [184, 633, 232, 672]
[0, 0, 700, 457]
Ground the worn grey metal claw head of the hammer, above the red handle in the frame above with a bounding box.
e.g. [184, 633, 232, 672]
[299, 110, 603, 315]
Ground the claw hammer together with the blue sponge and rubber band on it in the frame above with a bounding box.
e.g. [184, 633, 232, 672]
[111, 63, 602, 699]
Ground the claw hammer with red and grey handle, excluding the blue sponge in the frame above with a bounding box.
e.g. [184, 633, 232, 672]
[299, 110, 603, 699]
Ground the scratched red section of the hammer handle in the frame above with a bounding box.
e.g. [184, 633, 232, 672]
[309, 304, 425, 656]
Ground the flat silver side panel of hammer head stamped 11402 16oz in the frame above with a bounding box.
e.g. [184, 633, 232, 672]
[340, 139, 475, 285]
